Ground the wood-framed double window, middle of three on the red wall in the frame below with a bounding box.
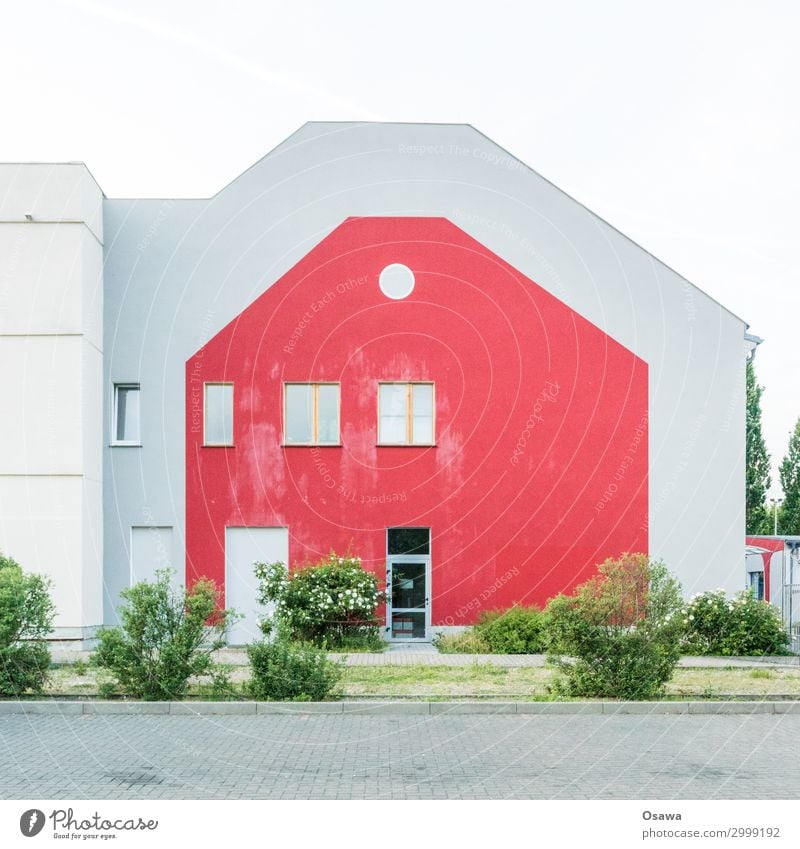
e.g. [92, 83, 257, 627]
[283, 383, 339, 445]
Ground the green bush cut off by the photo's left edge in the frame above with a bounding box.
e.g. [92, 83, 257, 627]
[0, 553, 55, 696]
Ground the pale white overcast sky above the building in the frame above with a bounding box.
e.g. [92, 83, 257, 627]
[0, 0, 800, 495]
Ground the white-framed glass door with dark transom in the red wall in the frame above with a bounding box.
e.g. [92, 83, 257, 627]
[386, 528, 431, 641]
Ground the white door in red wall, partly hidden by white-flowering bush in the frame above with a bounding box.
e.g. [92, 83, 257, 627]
[225, 528, 289, 646]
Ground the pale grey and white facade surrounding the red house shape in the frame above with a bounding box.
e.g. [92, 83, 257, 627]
[0, 123, 752, 641]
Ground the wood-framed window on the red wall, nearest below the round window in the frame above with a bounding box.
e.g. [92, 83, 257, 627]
[378, 383, 434, 445]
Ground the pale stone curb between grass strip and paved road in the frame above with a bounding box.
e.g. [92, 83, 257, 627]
[0, 700, 800, 717]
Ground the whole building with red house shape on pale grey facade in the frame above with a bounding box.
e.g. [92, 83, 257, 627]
[0, 123, 753, 643]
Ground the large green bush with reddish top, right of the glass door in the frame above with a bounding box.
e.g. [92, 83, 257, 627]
[547, 554, 683, 699]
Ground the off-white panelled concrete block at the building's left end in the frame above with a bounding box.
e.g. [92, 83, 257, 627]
[0, 163, 103, 639]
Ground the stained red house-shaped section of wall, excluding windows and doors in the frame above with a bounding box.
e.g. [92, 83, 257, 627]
[186, 218, 648, 625]
